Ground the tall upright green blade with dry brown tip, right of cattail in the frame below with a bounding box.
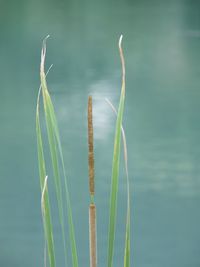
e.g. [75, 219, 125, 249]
[108, 36, 125, 267]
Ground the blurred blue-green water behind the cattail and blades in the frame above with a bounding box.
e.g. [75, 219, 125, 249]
[0, 0, 200, 267]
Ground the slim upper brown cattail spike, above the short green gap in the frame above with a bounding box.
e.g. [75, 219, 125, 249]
[88, 96, 94, 195]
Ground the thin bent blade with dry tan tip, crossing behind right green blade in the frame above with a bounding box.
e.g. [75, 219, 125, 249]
[106, 99, 130, 267]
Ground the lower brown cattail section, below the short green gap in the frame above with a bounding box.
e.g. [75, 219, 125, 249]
[89, 204, 97, 267]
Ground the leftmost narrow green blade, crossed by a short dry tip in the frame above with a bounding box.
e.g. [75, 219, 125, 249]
[36, 89, 56, 267]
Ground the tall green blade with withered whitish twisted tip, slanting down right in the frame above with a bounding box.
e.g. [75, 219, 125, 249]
[40, 37, 78, 267]
